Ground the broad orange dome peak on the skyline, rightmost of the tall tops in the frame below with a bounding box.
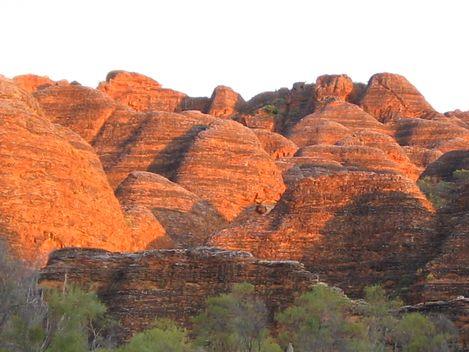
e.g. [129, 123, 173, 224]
[360, 73, 437, 122]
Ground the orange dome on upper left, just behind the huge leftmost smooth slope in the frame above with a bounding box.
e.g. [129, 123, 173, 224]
[34, 85, 118, 143]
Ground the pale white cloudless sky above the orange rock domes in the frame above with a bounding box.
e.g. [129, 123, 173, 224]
[0, 0, 469, 112]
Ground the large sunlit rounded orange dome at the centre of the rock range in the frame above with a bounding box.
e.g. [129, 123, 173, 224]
[175, 120, 285, 221]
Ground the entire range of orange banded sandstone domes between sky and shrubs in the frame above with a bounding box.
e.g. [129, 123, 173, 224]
[0, 71, 469, 342]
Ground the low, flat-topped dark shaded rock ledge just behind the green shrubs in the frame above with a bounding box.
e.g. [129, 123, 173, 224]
[41, 247, 315, 339]
